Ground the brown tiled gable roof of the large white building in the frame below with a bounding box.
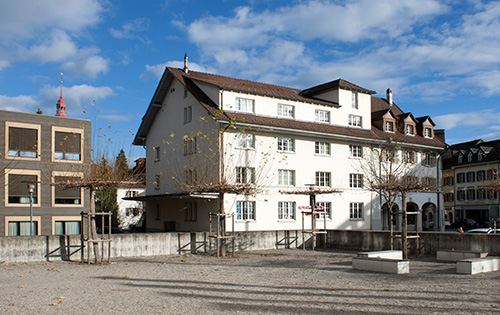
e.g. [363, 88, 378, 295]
[133, 67, 445, 148]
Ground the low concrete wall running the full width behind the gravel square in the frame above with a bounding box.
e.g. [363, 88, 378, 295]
[0, 230, 500, 263]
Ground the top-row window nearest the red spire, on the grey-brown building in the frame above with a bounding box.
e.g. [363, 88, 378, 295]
[52, 127, 83, 161]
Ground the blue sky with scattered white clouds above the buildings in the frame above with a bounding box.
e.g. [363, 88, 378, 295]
[0, 0, 500, 159]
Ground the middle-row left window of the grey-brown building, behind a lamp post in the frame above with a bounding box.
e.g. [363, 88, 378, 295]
[6, 170, 39, 205]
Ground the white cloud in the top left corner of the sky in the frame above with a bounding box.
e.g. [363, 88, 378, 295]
[0, 0, 104, 41]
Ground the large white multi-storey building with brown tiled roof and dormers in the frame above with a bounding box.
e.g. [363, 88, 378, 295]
[134, 67, 445, 231]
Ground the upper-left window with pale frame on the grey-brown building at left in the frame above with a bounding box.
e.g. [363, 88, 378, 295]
[5, 122, 40, 159]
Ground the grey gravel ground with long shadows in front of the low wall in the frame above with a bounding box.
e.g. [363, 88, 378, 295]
[0, 249, 500, 314]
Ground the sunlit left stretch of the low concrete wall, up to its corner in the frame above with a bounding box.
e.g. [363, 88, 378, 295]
[0, 231, 312, 263]
